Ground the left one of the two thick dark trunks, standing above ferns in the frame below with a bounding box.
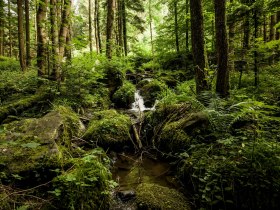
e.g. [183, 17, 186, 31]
[190, 0, 209, 94]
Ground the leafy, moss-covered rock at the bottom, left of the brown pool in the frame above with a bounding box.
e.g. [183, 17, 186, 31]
[52, 149, 114, 210]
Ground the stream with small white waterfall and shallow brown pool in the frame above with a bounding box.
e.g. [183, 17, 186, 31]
[109, 90, 186, 210]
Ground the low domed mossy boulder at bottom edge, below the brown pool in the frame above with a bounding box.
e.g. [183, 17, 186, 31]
[136, 184, 191, 210]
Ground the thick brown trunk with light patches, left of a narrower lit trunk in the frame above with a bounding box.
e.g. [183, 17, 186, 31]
[37, 0, 48, 76]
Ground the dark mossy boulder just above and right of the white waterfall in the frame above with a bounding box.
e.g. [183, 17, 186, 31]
[140, 80, 167, 107]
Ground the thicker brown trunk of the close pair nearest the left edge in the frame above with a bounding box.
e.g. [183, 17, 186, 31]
[17, 0, 26, 71]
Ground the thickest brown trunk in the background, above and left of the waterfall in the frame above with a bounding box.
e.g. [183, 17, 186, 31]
[106, 0, 114, 59]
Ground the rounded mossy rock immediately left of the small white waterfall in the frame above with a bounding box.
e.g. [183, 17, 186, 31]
[113, 81, 136, 108]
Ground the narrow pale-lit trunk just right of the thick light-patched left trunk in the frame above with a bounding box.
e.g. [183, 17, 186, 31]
[50, 0, 59, 80]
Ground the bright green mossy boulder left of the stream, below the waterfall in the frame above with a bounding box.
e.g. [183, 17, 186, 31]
[83, 109, 131, 150]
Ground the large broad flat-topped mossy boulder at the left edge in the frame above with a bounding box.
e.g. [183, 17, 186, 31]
[0, 107, 83, 178]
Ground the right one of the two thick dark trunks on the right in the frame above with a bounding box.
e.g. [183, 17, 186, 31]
[214, 0, 229, 97]
